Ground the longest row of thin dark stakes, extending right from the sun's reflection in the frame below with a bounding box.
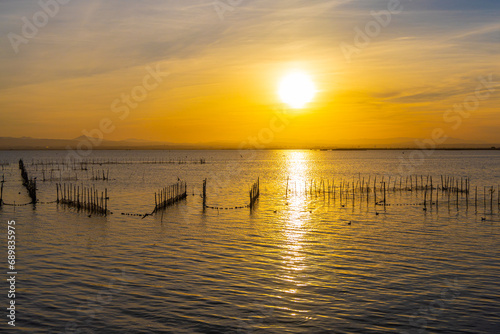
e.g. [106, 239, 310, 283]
[285, 175, 500, 212]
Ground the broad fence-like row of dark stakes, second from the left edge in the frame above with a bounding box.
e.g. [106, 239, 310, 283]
[56, 183, 109, 216]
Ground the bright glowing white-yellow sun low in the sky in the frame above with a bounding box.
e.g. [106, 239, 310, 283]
[278, 71, 316, 109]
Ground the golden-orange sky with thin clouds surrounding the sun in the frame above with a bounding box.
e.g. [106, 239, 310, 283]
[0, 0, 500, 146]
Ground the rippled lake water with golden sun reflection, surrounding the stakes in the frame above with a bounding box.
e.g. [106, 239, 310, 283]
[0, 151, 500, 333]
